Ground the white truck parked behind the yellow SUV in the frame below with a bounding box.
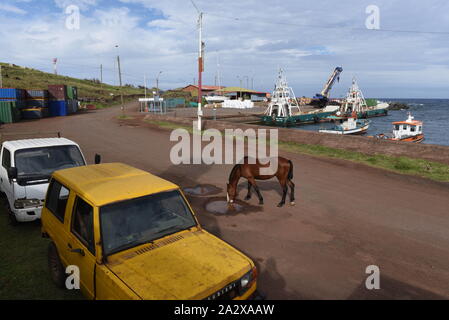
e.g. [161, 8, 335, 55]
[0, 138, 89, 225]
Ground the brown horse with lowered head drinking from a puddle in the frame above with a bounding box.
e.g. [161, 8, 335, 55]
[227, 157, 295, 207]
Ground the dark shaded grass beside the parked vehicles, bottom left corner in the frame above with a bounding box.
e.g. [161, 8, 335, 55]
[0, 198, 83, 300]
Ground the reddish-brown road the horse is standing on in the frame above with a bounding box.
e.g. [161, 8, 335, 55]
[0, 108, 449, 299]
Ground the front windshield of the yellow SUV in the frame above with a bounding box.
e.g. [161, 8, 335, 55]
[100, 190, 196, 256]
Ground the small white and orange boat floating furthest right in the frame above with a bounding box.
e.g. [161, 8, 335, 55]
[375, 113, 424, 143]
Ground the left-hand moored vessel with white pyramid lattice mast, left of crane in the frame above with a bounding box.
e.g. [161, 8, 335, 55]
[261, 69, 338, 126]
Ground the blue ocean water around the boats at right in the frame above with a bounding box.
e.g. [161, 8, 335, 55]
[295, 99, 449, 146]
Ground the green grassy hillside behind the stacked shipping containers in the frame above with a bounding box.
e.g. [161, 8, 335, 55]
[0, 63, 153, 104]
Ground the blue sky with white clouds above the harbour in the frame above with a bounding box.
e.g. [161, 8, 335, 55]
[0, 0, 449, 98]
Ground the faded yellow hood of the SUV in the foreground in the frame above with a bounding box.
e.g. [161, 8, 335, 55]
[107, 230, 252, 300]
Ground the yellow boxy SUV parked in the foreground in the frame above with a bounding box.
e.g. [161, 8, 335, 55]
[42, 163, 257, 300]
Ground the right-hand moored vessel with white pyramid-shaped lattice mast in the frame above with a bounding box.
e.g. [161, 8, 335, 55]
[340, 77, 389, 119]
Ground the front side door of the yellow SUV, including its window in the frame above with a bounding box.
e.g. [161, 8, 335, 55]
[67, 196, 96, 299]
